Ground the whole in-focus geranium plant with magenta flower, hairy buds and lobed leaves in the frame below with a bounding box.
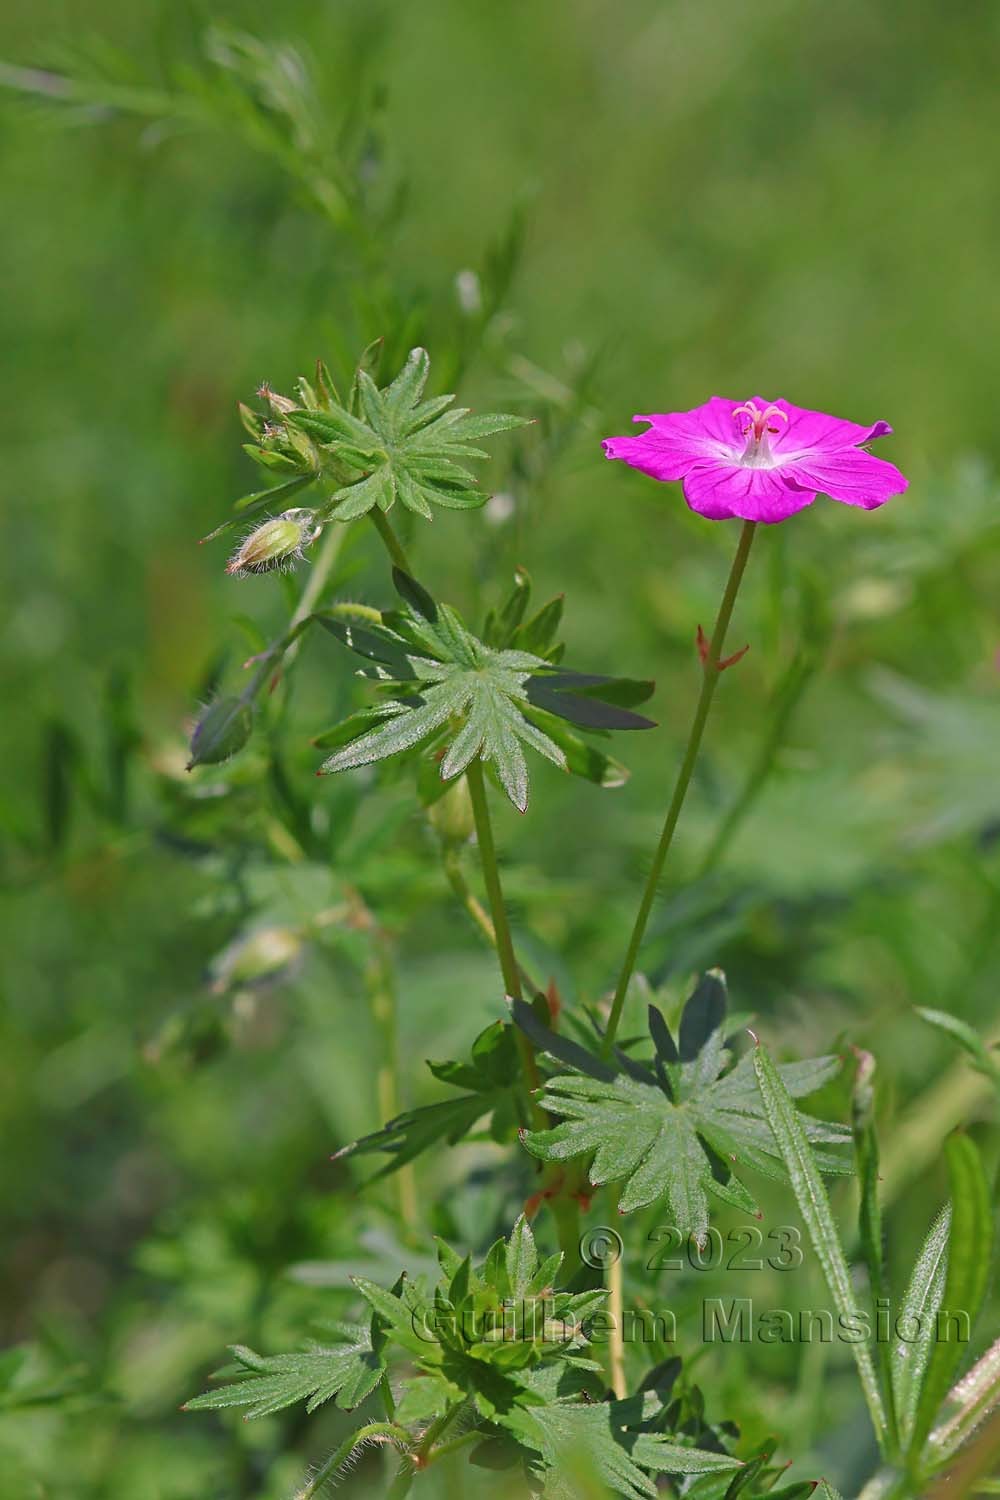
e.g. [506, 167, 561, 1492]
[177, 360, 1000, 1500]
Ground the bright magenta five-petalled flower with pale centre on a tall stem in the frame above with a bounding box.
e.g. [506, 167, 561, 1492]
[604, 396, 909, 522]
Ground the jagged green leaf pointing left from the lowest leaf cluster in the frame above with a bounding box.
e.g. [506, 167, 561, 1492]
[183, 1326, 385, 1422]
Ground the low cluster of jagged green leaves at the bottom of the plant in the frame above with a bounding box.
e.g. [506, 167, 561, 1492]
[187, 1217, 739, 1500]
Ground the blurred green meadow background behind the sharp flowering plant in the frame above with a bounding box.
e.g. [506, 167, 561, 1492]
[0, 0, 1000, 1500]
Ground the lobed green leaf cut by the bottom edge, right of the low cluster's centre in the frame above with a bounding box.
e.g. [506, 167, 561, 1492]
[498, 1398, 741, 1500]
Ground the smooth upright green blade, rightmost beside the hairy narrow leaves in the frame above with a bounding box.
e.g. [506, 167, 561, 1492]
[909, 1136, 993, 1457]
